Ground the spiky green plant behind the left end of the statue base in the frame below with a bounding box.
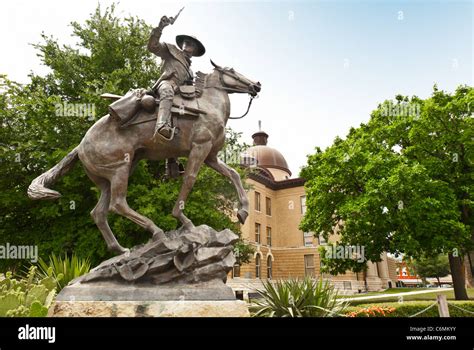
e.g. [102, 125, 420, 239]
[38, 253, 91, 292]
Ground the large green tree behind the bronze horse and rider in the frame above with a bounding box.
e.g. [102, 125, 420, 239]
[0, 6, 252, 269]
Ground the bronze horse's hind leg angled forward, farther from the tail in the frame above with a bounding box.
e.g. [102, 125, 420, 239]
[109, 167, 166, 240]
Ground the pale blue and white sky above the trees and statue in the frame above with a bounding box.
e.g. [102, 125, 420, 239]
[0, 0, 474, 176]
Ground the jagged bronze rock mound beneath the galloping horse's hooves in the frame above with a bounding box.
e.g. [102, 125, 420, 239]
[70, 225, 239, 288]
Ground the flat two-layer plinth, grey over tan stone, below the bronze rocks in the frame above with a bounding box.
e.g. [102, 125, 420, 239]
[48, 281, 250, 317]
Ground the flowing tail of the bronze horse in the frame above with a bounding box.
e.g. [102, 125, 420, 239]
[28, 146, 79, 199]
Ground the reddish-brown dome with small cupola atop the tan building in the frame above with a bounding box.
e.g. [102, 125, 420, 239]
[243, 131, 291, 177]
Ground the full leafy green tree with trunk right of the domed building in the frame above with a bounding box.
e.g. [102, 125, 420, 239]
[301, 86, 474, 299]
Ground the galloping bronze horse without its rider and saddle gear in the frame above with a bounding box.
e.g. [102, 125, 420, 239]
[28, 61, 260, 253]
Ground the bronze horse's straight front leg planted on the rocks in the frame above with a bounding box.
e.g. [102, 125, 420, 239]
[172, 141, 212, 229]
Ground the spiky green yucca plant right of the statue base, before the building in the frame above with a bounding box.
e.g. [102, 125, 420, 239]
[250, 277, 348, 317]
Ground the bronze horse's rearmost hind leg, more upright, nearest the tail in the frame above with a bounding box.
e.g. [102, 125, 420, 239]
[87, 172, 129, 254]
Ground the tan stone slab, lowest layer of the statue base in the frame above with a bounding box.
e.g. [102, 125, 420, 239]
[48, 300, 250, 317]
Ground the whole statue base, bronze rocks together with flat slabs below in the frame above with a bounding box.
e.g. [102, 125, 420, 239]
[49, 225, 249, 317]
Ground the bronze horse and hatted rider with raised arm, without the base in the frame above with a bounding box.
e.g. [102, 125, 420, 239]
[28, 8, 261, 253]
